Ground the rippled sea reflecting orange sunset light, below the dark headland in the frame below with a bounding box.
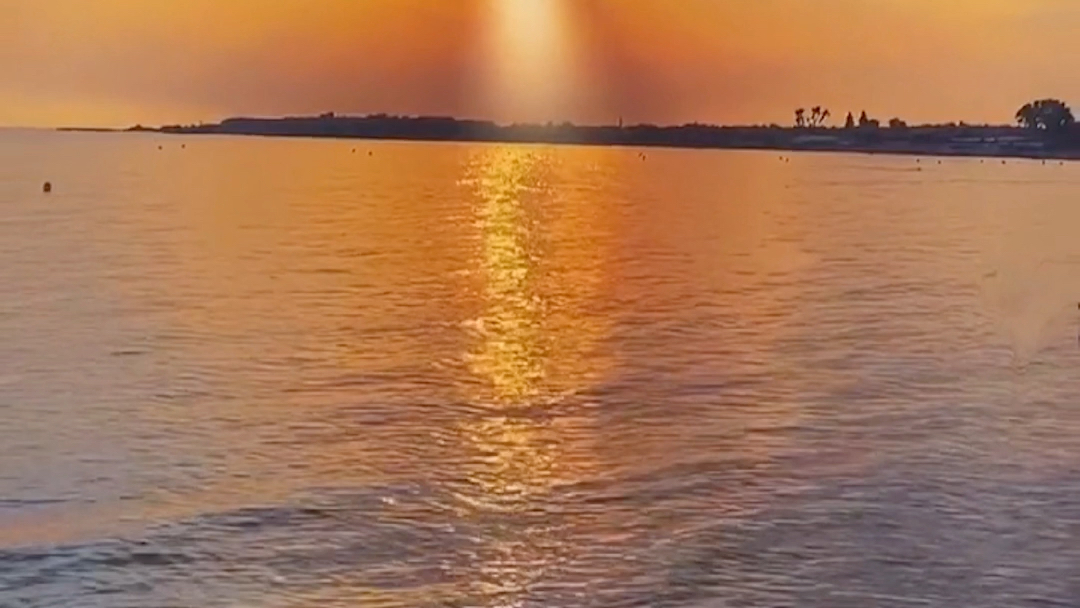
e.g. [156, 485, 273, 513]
[0, 132, 1080, 608]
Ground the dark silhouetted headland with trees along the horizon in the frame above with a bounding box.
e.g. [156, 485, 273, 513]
[65, 99, 1080, 160]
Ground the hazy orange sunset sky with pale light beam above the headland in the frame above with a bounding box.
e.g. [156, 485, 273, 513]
[0, 0, 1080, 126]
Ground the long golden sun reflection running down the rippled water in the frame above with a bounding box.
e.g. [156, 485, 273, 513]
[451, 147, 609, 606]
